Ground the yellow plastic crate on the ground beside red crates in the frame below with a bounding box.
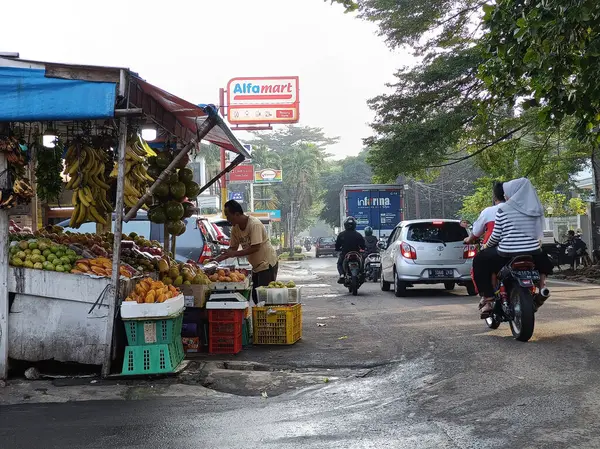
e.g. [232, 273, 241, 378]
[252, 304, 302, 345]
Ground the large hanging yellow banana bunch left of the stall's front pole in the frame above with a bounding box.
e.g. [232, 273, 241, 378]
[65, 143, 113, 228]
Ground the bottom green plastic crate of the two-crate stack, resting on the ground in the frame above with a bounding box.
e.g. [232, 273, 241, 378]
[121, 337, 185, 376]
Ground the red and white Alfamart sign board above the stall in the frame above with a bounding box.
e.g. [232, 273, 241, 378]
[227, 76, 300, 125]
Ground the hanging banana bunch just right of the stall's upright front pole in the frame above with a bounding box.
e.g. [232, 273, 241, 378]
[110, 136, 156, 210]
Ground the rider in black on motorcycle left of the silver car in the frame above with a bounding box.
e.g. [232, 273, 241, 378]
[335, 217, 366, 296]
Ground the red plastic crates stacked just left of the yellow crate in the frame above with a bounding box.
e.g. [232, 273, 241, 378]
[208, 309, 246, 354]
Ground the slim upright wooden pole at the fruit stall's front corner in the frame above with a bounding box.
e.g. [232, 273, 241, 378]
[102, 70, 128, 377]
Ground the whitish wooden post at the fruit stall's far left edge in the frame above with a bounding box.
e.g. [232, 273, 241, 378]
[0, 124, 9, 379]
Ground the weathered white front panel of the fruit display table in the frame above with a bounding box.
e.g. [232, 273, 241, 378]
[8, 267, 135, 365]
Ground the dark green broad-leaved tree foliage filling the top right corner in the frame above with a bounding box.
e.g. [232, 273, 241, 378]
[480, 0, 600, 197]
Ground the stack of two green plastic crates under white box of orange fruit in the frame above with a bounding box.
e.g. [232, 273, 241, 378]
[122, 311, 185, 375]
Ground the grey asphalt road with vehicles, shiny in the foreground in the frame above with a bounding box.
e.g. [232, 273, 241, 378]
[0, 254, 600, 449]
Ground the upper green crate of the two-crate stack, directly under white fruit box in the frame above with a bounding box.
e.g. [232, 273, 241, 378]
[123, 313, 183, 346]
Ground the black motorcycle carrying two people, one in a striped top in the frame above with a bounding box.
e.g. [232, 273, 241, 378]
[485, 256, 550, 341]
